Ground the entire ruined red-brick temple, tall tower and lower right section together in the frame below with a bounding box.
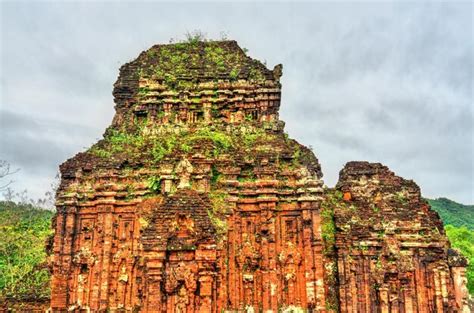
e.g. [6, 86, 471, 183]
[51, 41, 467, 312]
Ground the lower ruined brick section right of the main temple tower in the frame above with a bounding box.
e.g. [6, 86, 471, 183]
[334, 162, 468, 312]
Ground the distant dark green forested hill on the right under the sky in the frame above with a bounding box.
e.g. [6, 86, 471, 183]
[426, 198, 474, 230]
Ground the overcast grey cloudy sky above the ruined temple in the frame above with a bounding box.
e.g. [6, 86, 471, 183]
[0, 1, 474, 204]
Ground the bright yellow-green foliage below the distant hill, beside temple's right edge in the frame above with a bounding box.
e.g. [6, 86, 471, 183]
[445, 224, 474, 295]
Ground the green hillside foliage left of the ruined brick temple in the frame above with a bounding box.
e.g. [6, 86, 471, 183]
[0, 201, 53, 301]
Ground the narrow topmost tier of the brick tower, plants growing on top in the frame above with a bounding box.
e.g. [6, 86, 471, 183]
[113, 41, 282, 126]
